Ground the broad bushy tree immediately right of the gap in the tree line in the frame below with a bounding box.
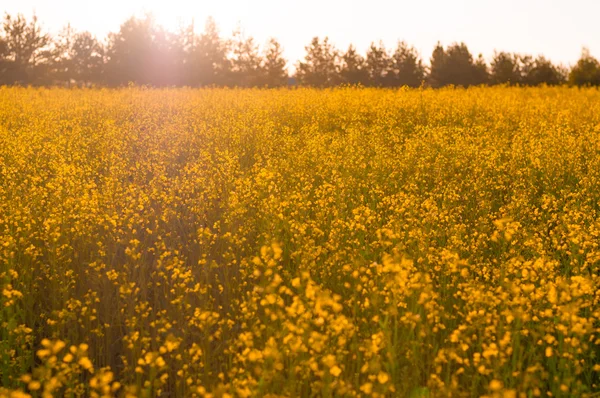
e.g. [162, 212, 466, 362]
[296, 37, 339, 87]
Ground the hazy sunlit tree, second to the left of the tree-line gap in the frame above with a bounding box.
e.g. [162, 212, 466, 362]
[231, 29, 263, 87]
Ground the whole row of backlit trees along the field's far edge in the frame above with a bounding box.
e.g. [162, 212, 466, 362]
[0, 14, 600, 87]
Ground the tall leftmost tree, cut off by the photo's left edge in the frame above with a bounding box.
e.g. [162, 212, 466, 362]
[0, 14, 51, 84]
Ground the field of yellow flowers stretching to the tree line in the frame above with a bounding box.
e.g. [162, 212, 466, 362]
[0, 87, 600, 398]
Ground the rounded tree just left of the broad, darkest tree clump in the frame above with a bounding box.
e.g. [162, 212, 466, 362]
[388, 41, 425, 87]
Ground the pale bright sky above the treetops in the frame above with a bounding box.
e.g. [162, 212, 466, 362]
[0, 0, 600, 66]
